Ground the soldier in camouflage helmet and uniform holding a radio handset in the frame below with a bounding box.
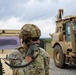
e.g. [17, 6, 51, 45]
[9, 24, 50, 75]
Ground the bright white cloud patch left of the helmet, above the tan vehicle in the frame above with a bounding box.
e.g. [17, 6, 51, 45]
[0, 17, 23, 30]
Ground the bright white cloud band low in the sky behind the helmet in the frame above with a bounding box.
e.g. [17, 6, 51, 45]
[0, 17, 55, 37]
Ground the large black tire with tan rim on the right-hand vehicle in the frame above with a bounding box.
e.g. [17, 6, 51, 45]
[53, 45, 67, 68]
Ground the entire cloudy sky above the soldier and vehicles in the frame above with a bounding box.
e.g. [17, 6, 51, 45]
[0, 0, 76, 38]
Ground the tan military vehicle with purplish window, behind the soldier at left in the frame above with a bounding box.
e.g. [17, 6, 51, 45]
[0, 30, 21, 75]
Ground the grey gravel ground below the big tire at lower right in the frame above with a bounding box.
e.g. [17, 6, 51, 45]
[50, 59, 76, 75]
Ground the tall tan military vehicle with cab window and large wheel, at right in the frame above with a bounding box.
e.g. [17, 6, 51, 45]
[51, 9, 76, 68]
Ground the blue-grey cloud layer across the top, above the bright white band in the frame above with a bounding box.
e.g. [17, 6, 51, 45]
[0, 0, 76, 21]
